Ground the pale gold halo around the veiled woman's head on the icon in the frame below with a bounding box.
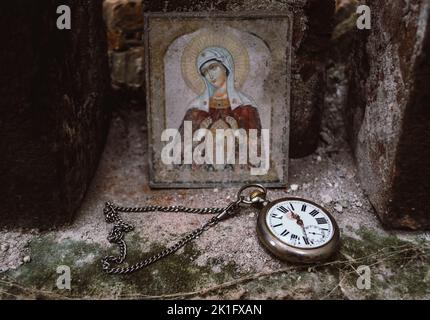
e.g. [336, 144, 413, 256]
[181, 29, 249, 94]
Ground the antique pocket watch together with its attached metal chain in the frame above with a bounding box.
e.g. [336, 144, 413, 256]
[102, 184, 340, 274]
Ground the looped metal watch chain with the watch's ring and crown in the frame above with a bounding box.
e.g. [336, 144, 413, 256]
[102, 185, 266, 274]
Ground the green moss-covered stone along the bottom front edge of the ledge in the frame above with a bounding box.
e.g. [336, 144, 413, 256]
[2, 229, 430, 299]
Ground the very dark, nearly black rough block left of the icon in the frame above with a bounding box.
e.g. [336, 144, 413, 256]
[0, 0, 110, 228]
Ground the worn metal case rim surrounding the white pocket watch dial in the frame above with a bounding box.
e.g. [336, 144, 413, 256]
[257, 197, 340, 263]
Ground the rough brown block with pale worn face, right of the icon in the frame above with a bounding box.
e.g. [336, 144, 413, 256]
[346, 0, 430, 229]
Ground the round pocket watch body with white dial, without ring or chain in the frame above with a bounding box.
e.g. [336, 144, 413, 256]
[252, 197, 339, 263]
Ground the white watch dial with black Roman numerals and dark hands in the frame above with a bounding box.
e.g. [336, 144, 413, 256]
[266, 199, 334, 249]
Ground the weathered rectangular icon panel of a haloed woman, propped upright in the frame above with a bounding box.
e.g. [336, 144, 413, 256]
[146, 14, 291, 187]
